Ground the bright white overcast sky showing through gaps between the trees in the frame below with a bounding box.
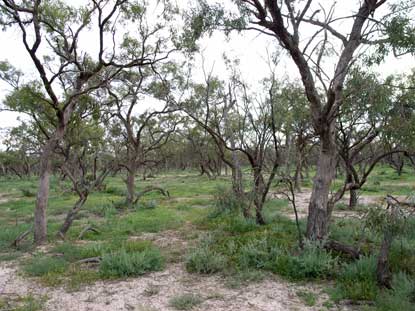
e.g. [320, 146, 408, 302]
[0, 0, 415, 143]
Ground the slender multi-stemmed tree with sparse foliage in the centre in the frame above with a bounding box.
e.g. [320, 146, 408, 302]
[181, 68, 280, 224]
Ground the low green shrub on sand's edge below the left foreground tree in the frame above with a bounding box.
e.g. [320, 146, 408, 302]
[24, 256, 68, 276]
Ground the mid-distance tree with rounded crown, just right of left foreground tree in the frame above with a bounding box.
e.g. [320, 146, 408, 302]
[106, 64, 179, 205]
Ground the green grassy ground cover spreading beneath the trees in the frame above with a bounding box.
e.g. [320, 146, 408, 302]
[0, 166, 415, 310]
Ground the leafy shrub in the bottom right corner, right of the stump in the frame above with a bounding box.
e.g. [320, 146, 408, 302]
[375, 273, 415, 311]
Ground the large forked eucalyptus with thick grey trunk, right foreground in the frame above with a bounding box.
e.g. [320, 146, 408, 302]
[190, 0, 410, 240]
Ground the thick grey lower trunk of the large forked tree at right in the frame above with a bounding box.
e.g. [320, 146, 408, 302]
[306, 122, 336, 240]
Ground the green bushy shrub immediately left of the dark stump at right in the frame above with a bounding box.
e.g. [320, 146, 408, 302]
[333, 256, 378, 301]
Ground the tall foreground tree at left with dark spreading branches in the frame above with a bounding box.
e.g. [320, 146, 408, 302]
[0, 0, 180, 244]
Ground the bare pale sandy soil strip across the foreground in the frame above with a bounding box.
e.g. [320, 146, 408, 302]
[0, 264, 354, 311]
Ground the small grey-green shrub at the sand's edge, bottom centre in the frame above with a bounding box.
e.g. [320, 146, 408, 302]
[186, 245, 227, 274]
